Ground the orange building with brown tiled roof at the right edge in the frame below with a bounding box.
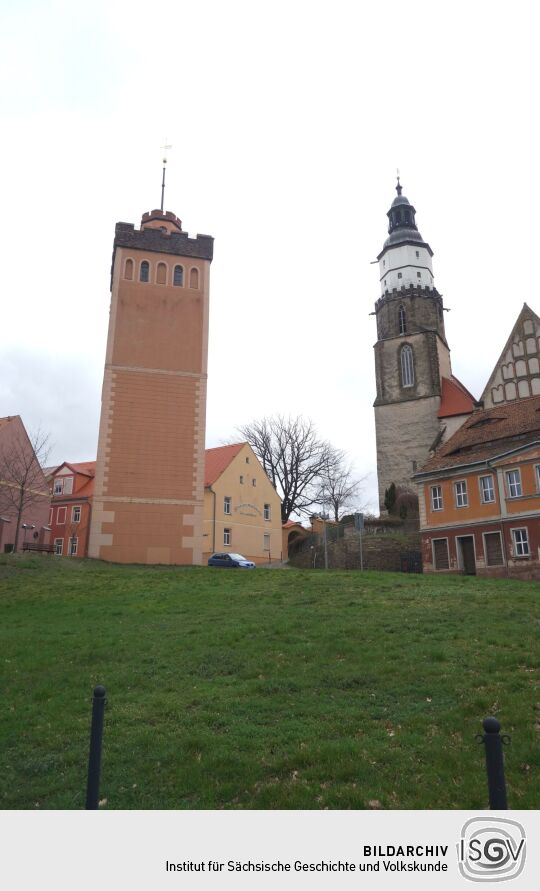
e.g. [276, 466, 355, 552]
[416, 397, 540, 579]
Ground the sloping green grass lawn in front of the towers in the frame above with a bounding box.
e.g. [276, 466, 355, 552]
[0, 556, 540, 809]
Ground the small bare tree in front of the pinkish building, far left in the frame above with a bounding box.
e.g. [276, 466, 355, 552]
[0, 422, 50, 551]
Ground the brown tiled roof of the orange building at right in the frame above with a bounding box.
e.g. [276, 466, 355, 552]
[415, 396, 540, 477]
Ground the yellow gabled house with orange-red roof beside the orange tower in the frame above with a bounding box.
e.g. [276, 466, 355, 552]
[203, 442, 282, 563]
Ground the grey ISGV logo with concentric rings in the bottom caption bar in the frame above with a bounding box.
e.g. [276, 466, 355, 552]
[457, 817, 526, 882]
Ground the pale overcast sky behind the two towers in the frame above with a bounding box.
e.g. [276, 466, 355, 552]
[0, 0, 540, 508]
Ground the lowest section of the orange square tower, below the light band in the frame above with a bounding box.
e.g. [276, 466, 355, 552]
[88, 499, 203, 566]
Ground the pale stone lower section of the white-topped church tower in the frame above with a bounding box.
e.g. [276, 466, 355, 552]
[375, 396, 441, 510]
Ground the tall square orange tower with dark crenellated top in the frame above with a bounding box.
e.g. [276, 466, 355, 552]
[89, 210, 213, 564]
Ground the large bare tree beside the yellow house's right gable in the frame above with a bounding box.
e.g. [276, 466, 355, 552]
[238, 415, 342, 523]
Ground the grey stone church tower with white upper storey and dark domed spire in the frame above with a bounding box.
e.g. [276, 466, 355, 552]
[374, 177, 458, 509]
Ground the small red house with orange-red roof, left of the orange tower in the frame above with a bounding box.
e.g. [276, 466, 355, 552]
[49, 461, 96, 557]
